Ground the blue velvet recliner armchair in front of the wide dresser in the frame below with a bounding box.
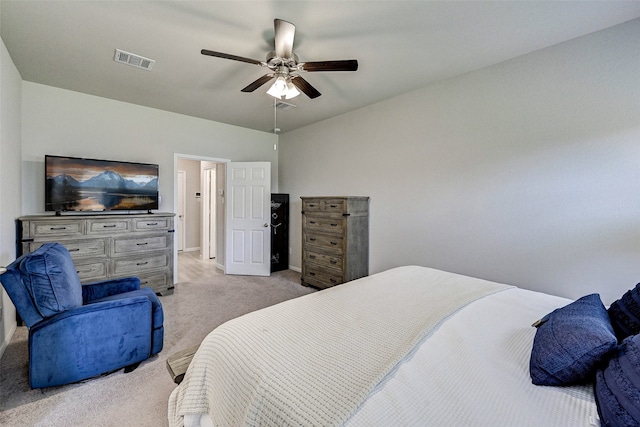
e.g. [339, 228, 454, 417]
[0, 243, 164, 388]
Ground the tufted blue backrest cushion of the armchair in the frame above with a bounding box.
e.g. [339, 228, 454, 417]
[18, 243, 82, 318]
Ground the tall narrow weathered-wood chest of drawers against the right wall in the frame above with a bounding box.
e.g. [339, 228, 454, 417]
[301, 197, 369, 289]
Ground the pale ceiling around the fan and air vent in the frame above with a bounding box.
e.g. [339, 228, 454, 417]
[0, 0, 640, 132]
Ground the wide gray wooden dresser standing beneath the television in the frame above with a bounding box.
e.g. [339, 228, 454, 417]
[18, 213, 175, 295]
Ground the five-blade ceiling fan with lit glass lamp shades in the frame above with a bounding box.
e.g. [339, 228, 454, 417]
[200, 19, 358, 99]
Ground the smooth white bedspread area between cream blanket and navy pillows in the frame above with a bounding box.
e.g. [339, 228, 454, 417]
[346, 288, 600, 427]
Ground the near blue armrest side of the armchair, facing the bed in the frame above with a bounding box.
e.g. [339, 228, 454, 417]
[29, 296, 152, 388]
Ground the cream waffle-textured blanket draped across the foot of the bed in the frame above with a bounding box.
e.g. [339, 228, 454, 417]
[169, 266, 509, 426]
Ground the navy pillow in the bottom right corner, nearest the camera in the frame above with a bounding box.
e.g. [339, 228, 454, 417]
[595, 335, 640, 426]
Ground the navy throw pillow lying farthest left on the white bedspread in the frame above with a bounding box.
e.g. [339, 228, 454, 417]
[529, 294, 618, 386]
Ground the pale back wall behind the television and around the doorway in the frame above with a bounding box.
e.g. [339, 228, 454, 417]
[22, 81, 278, 214]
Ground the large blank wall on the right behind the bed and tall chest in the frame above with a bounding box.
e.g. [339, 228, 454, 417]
[279, 20, 640, 303]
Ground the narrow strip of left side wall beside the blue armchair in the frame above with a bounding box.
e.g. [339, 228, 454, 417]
[0, 37, 22, 357]
